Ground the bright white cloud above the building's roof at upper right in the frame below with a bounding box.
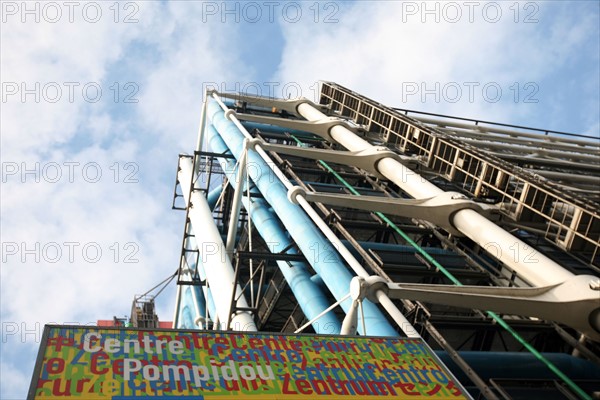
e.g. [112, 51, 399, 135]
[277, 2, 598, 128]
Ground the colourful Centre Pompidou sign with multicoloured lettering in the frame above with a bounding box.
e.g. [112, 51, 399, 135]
[29, 326, 467, 400]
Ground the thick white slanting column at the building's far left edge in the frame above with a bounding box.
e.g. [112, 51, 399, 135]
[178, 157, 257, 331]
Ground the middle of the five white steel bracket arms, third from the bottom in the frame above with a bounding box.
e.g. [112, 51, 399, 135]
[248, 139, 418, 179]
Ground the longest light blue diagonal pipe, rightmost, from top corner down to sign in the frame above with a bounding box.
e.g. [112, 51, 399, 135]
[207, 101, 398, 336]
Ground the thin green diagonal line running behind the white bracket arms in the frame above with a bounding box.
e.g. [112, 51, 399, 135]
[291, 135, 592, 400]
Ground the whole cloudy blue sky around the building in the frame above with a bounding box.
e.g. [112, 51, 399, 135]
[0, 0, 600, 399]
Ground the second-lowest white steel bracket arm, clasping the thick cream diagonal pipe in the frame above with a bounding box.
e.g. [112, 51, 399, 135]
[288, 186, 495, 236]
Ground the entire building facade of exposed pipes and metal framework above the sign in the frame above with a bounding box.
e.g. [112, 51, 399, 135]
[173, 82, 600, 399]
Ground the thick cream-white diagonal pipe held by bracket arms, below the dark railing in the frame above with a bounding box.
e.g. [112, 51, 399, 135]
[298, 103, 573, 286]
